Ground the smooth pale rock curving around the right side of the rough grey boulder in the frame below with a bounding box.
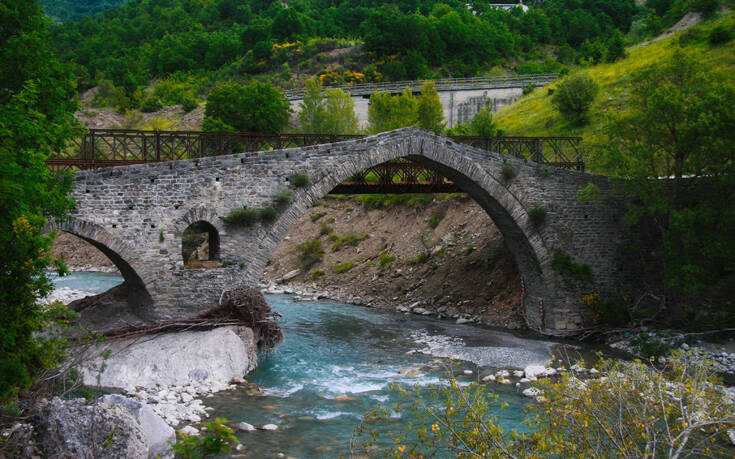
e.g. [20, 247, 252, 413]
[100, 394, 176, 459]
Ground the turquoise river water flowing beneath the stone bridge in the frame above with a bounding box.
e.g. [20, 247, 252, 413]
[56, 273, 592, 458]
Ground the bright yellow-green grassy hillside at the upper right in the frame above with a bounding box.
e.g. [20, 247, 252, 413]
[496, 12, 735, 169]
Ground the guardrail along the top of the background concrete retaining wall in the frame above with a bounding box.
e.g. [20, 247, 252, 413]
[284, 73, 559, 100]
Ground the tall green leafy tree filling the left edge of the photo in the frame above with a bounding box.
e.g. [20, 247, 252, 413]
[0, 0, 77, 401]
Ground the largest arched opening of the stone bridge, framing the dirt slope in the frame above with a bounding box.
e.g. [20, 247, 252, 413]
[262, 157, 535, 328]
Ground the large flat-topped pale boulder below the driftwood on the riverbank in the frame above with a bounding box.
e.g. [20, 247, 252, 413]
[82, 326, 257, 392]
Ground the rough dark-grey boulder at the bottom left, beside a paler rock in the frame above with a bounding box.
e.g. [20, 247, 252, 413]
[35, 397, 148, 459]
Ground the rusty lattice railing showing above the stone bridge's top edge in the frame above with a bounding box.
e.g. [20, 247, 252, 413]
[47, 129, 584, 170]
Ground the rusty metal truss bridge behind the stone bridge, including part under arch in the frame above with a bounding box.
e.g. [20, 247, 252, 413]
[47, 129, 585, 194]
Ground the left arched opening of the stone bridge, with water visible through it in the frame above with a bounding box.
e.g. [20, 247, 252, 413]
[53, 232, 152, 329]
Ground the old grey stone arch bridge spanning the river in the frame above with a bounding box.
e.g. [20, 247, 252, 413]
[55, 128, 621, 335]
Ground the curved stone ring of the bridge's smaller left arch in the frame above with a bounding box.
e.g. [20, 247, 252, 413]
[49, 219, 151, 306]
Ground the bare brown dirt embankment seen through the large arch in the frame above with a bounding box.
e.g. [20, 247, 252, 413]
[263, 197, 524, 328]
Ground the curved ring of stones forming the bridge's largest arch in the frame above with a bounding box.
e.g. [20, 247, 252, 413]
[264, 130, 551, 331]
